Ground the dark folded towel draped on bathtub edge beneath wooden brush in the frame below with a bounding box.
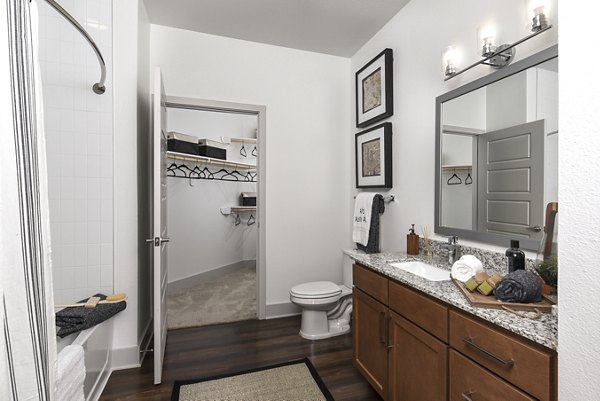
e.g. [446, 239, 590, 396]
[56, 294, 127, 338]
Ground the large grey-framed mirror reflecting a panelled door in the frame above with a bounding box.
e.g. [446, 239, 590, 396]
[435, 46, 558, 250]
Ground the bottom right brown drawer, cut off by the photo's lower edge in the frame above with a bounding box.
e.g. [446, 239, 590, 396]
[449, 350, 535, 401]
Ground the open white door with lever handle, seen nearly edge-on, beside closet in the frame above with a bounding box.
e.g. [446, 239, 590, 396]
[149, 68, 169, 384]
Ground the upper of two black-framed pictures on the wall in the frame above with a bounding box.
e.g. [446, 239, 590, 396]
[355, 48, 394, 128]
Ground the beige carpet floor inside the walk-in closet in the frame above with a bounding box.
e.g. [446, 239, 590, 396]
[167, 266, 256, 329]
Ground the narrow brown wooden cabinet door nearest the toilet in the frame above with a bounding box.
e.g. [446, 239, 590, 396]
[352, 287, 388, 398]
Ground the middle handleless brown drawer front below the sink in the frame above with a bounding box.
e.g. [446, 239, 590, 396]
[389, 281, 448, 343]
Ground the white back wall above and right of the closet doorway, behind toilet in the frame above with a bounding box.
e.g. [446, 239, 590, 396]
[150, 25, 353, 314]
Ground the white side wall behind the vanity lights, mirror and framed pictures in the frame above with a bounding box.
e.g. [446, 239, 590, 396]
[347, 0, 558, 251]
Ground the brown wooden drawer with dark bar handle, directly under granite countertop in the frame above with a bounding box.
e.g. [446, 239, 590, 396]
[450, 311, 553, 401]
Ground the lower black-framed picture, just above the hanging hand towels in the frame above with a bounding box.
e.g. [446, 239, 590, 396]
[355, 122, 392, 188]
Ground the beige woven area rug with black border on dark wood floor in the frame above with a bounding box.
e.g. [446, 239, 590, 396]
[171, 358, 333, 401]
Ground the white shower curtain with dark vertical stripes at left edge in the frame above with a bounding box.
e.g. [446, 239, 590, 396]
[0, 0, 56, 400]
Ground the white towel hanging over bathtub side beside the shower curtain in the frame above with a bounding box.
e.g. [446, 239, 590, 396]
[55, 345, 85, 401]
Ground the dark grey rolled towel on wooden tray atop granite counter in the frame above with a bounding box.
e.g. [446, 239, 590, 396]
[494, 270, 542, 303]
